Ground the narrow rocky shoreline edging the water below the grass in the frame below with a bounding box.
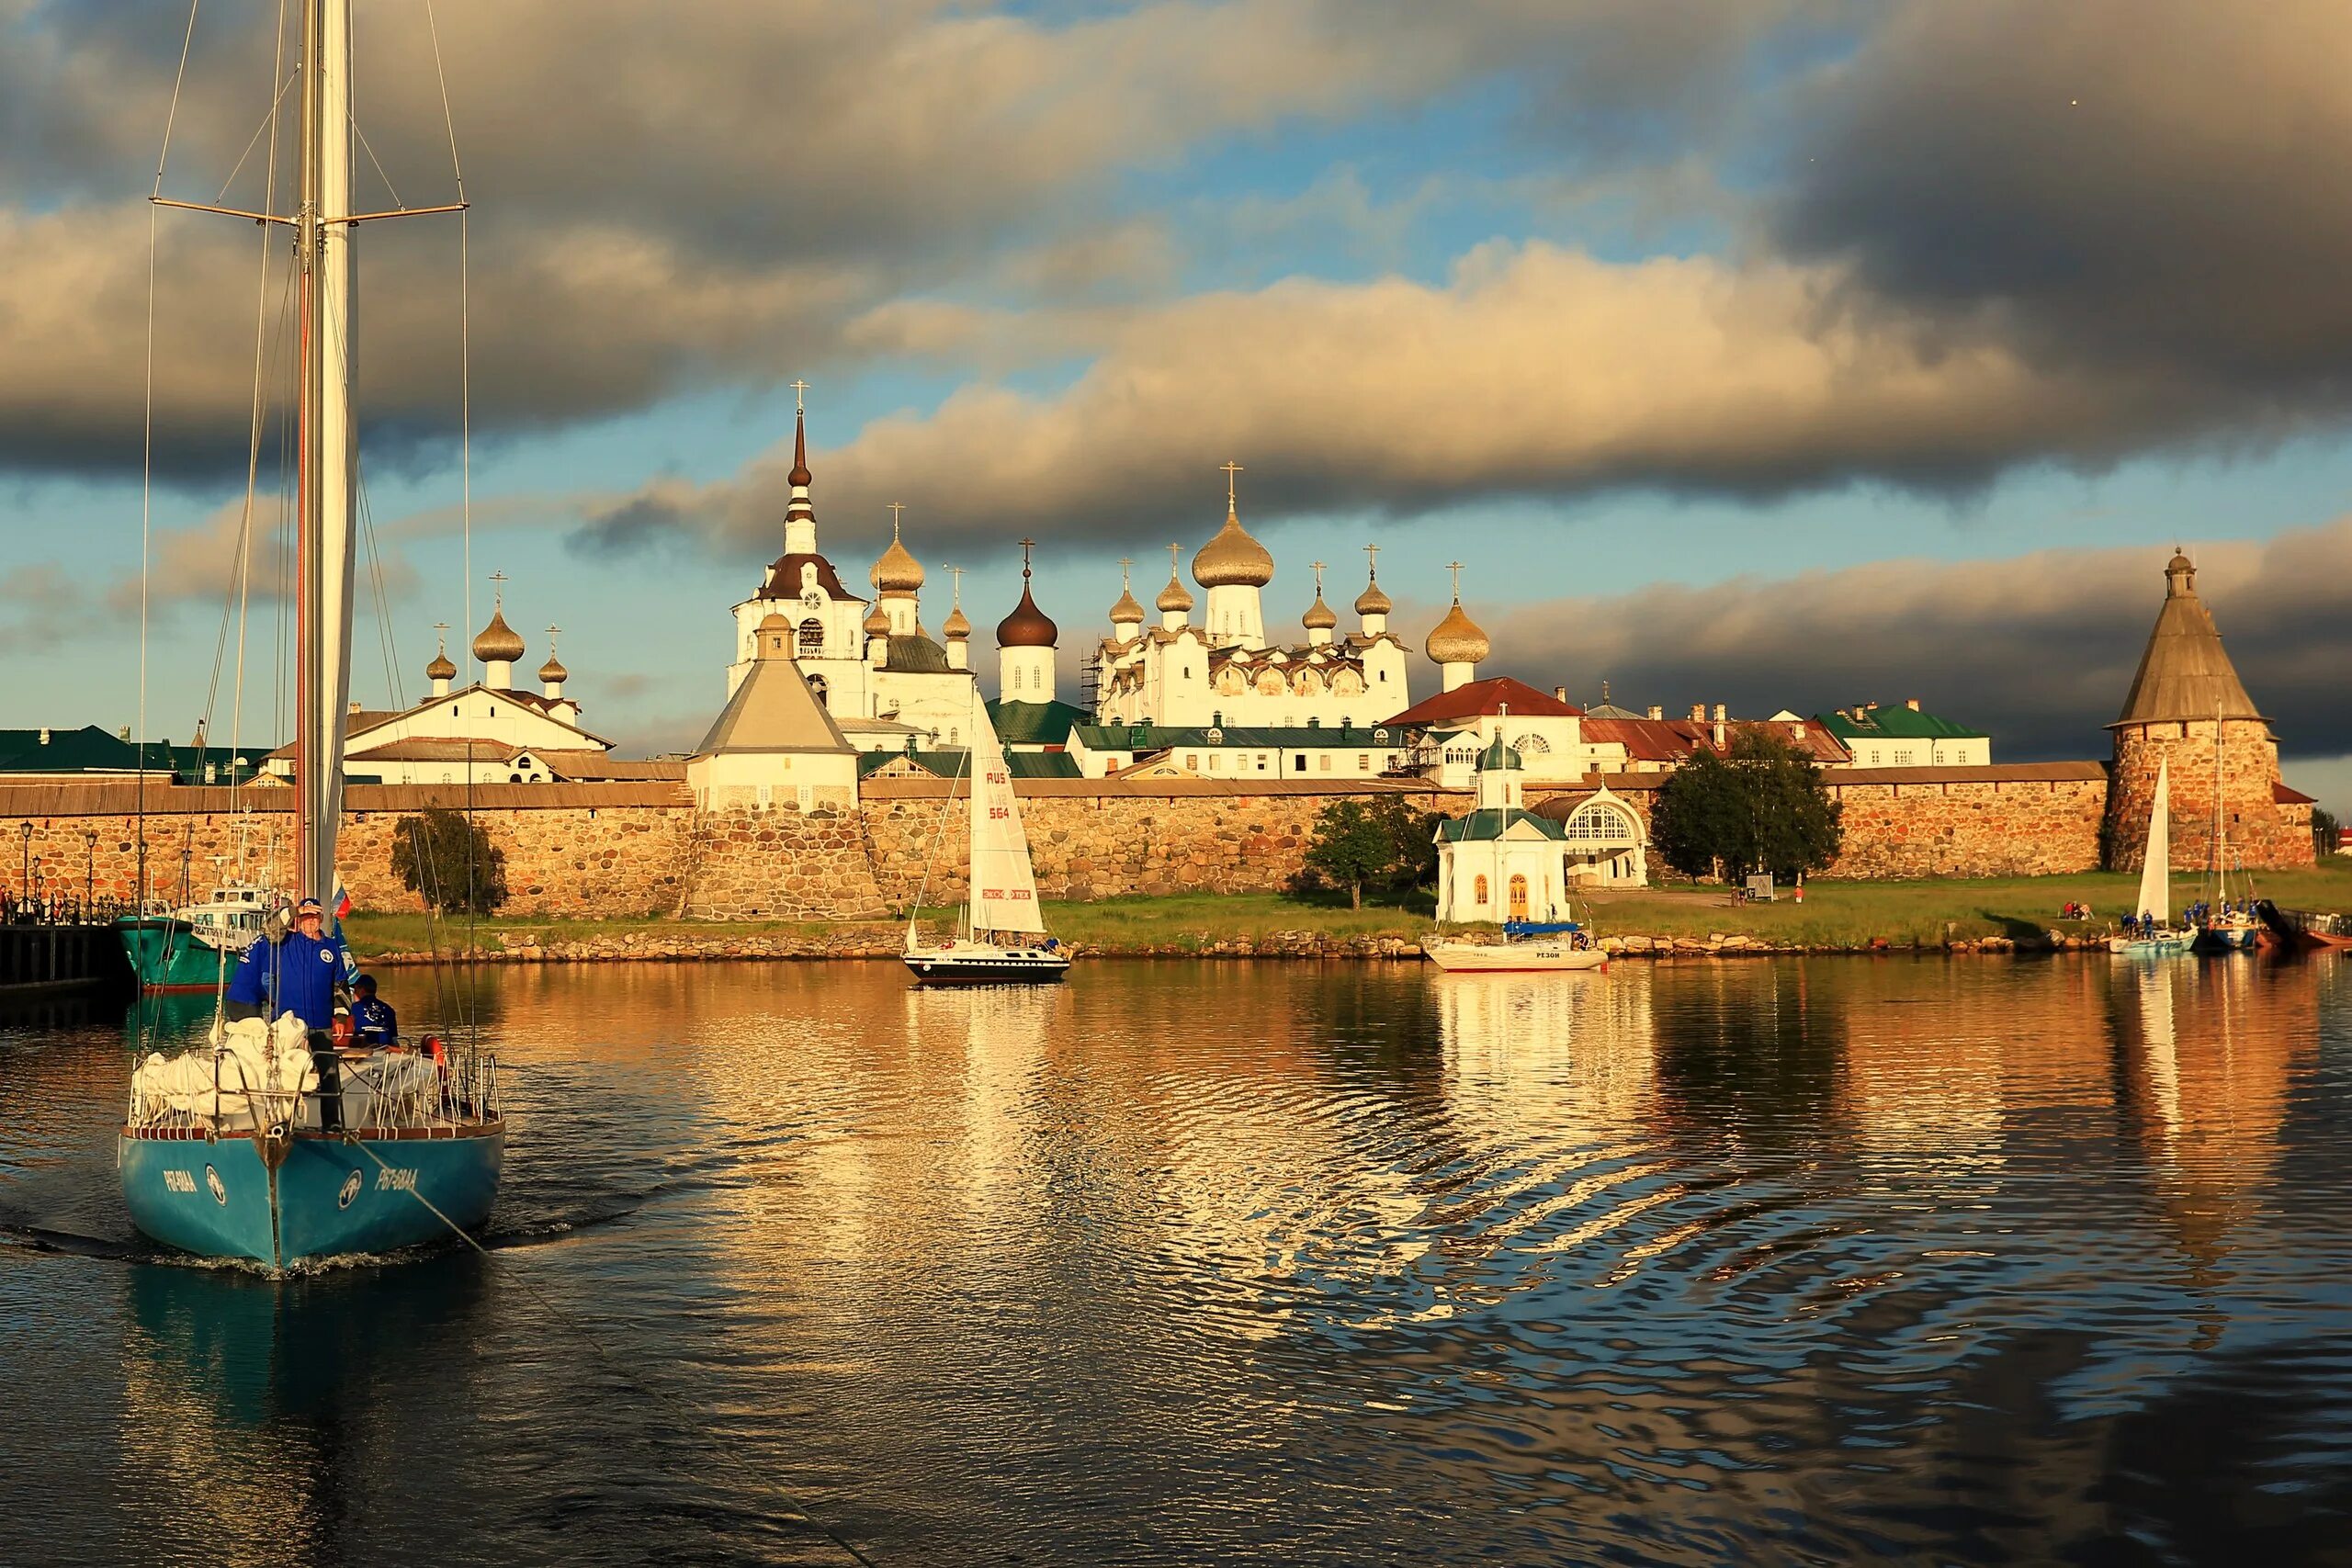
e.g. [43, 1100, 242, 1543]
[365, 926, 2108, 968]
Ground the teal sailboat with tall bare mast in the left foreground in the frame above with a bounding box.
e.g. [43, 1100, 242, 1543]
[115, 0, 505, 1272]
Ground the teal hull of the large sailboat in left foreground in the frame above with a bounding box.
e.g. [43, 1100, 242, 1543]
[115, 1122, 505, 1269]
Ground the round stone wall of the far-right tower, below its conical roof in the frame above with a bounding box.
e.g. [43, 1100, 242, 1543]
[2108, 719, 2314, 872]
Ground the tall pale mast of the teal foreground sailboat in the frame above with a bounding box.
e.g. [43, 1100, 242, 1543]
[294, 0, 357, 903]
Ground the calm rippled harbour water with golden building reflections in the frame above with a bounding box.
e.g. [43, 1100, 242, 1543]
[0, 957, 2352, 1565]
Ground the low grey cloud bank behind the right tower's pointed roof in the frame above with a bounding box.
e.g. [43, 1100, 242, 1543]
[1487, 520, 2352, 761]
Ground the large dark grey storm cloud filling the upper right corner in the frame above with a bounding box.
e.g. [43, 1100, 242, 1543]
[1778, 0, 2352, 401]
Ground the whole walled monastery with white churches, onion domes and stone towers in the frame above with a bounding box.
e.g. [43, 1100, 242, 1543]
[0, 413, 2314, 919]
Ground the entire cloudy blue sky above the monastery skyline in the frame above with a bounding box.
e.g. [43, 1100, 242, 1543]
[0, 0, 2352, 811]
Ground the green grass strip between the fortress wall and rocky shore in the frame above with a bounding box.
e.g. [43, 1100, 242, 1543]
[348, 858, 2352, 959]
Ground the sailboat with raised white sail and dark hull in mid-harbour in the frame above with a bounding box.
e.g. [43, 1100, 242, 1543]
[906, 691, 1070, 985]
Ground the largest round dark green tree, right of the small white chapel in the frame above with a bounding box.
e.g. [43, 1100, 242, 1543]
[1649, 727, 1844, 879]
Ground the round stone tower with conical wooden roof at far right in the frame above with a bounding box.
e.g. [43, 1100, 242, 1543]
[2108, 555, 2312, 872]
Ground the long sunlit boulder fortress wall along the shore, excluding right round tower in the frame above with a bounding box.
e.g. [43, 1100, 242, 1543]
[0, 764, 2154, 919]
